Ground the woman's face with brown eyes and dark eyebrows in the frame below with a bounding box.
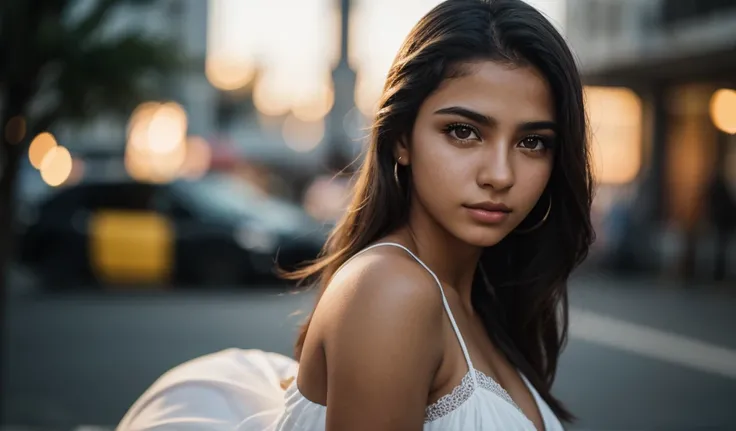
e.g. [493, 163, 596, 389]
[406, 61, 556, 247]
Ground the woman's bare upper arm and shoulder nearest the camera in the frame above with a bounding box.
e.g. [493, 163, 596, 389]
[320, 257, 443, 431]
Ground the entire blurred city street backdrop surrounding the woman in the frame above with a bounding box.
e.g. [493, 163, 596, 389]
[0, 0, 736, 431]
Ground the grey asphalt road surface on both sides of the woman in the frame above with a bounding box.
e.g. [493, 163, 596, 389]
[4, 275, 736, 430]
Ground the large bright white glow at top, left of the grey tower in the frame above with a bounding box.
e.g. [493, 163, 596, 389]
[206, 0, 340, 118]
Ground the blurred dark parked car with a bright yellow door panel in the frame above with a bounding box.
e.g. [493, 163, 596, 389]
[20, 175, 326, 288]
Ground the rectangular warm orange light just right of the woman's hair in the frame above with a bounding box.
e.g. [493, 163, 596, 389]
[585, 87, 642, 184]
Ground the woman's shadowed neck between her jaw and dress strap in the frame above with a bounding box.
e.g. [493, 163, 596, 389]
[397, 197, 483, 310]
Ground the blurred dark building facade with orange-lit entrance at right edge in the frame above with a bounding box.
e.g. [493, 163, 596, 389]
[566, 0, 736, 276]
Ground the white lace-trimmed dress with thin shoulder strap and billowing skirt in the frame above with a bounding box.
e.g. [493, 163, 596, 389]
[117, 243, 564, 431]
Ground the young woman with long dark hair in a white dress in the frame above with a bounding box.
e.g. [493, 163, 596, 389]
[121, 0, 593, 431]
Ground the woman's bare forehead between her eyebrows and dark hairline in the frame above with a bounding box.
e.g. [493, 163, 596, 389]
[422, 61, 554, 123]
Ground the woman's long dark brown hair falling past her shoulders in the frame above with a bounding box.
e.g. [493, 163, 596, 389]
[288, 0, 594, 421]
